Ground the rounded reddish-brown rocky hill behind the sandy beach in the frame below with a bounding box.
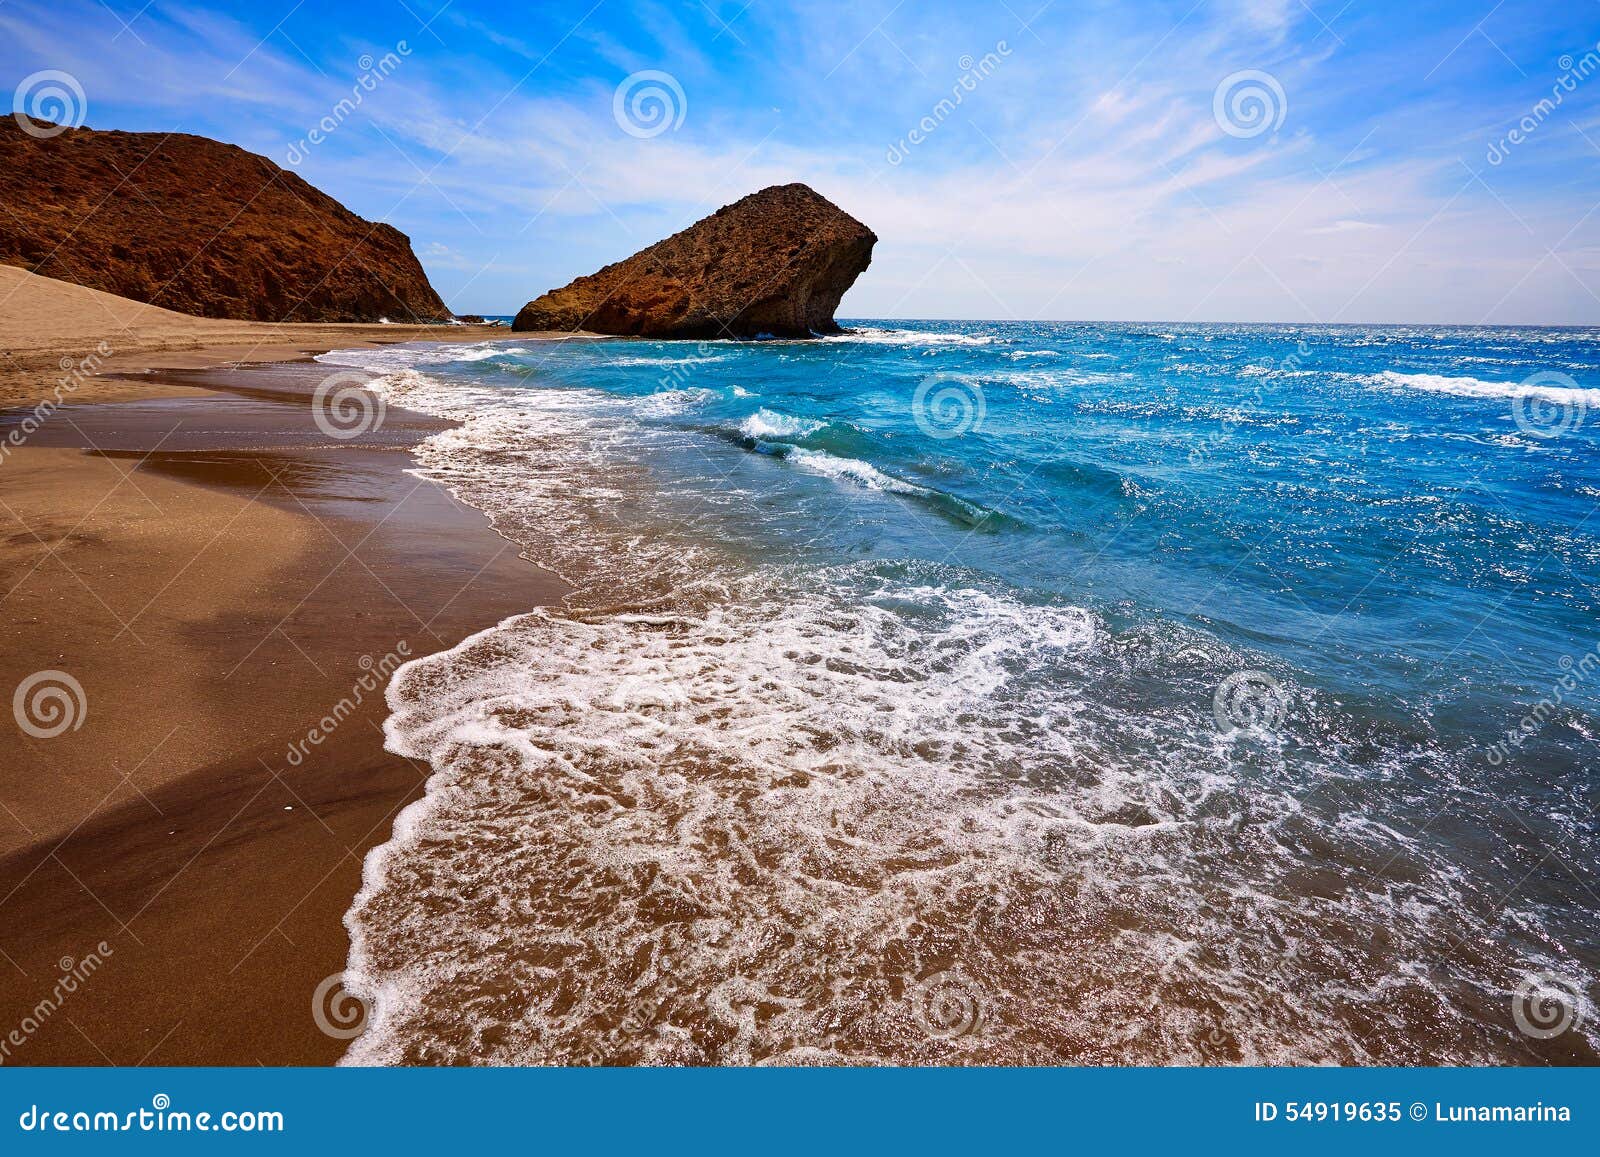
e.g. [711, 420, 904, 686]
[0, 117, 450, 322]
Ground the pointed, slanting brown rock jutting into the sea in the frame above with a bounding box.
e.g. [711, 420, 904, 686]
[512, 184, 878, 338]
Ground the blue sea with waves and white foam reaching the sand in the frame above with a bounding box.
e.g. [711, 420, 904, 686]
[323, 322, 1600, 1063]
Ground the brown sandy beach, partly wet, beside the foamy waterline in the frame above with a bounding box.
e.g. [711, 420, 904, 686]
[0, 269, 562, 1064]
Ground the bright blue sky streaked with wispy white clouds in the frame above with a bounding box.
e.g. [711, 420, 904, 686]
[0, 0, 1600, 325]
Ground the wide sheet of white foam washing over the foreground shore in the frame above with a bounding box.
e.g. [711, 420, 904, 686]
[346, 544, 1574, 1064]
